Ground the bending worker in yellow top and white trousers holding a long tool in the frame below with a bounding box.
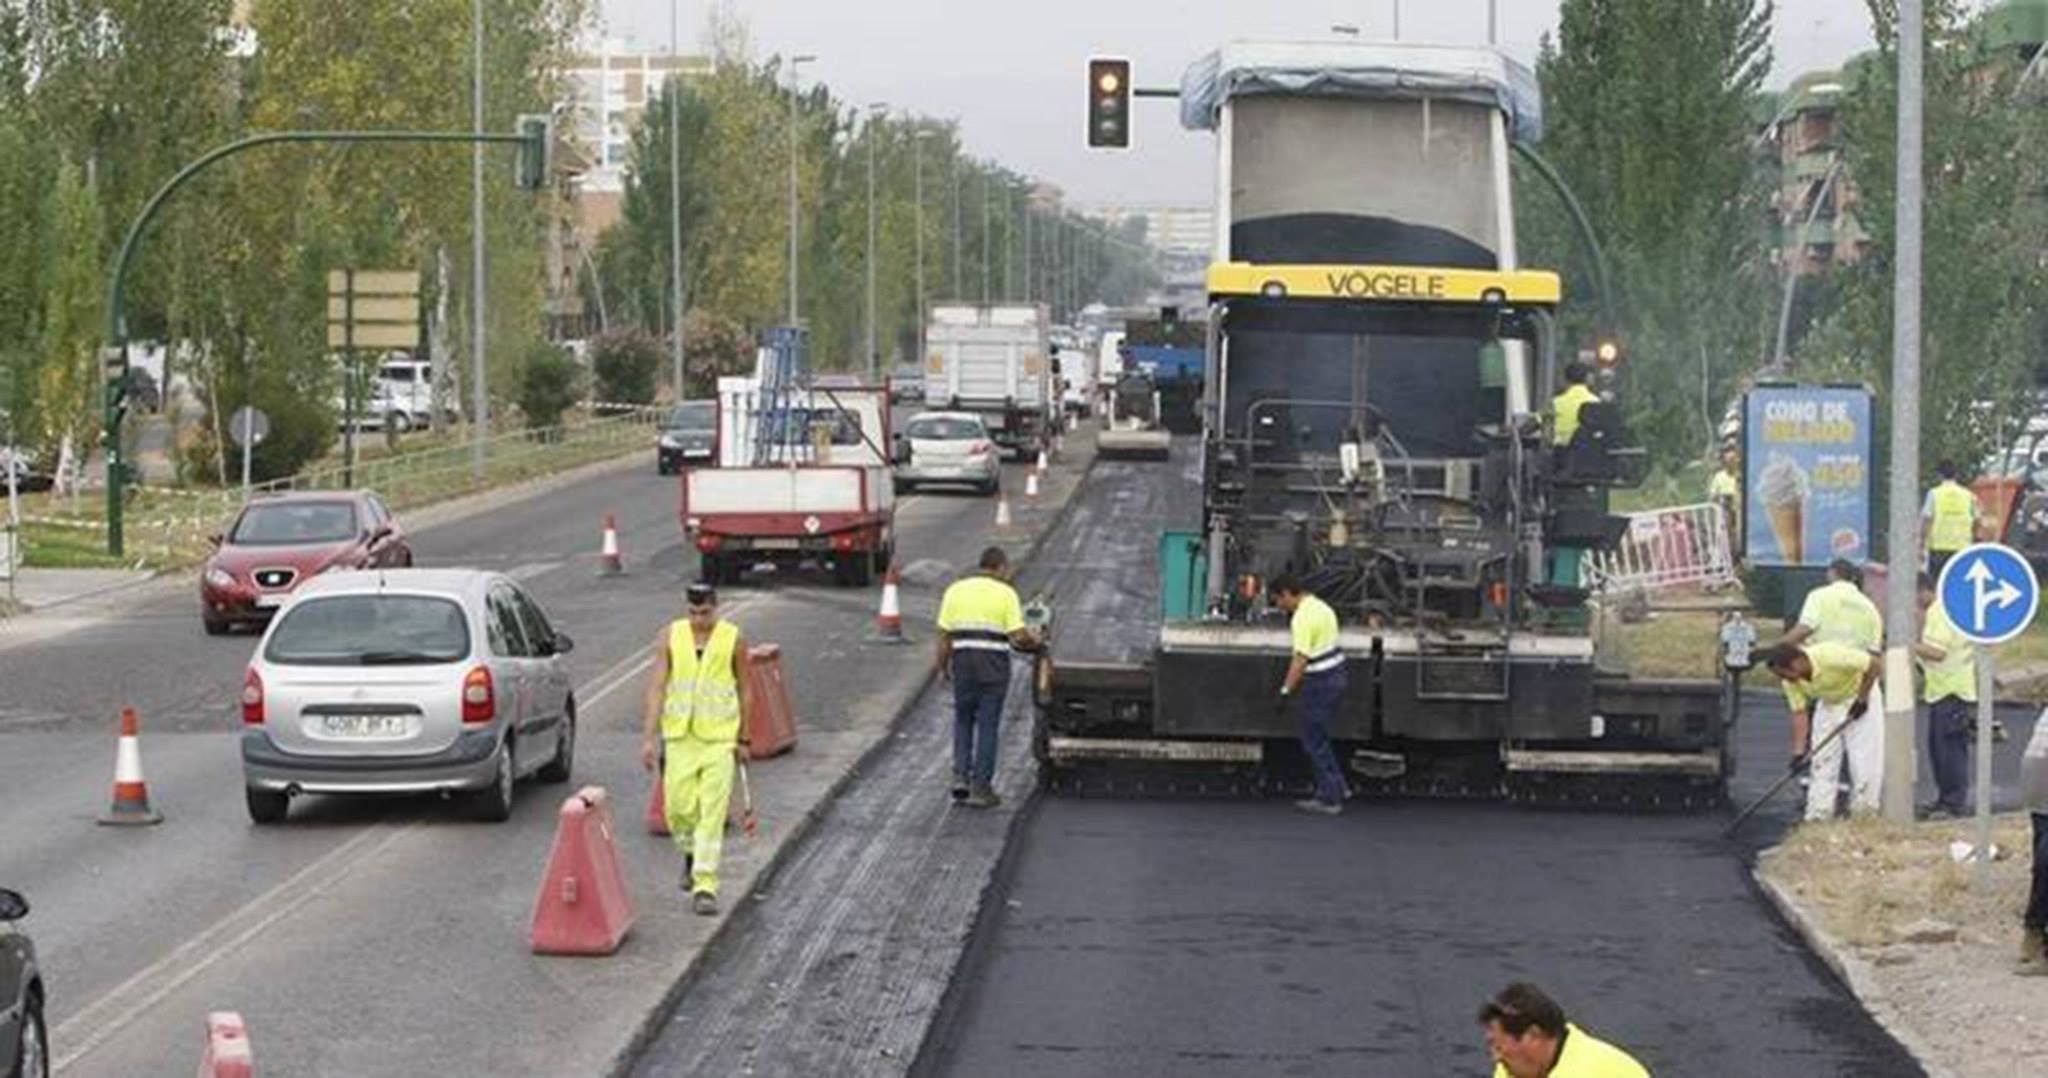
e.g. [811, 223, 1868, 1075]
[1757, 644, 1884, 820]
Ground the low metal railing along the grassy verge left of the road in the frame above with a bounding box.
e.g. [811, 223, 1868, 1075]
[23, 406, 666, 566]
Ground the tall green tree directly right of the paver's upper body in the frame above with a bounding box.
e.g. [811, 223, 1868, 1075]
[1518, 0, 1774, 457]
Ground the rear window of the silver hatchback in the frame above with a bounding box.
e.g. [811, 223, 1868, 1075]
[264, 594, 469, 666]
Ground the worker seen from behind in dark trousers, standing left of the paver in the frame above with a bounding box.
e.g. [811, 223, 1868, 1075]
[938, 547, 1038, 807]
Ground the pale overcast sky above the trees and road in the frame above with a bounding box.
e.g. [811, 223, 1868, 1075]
[598, 0, 1900, 205]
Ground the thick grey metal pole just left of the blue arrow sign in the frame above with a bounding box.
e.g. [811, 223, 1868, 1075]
[1880, 0, 1927, 824]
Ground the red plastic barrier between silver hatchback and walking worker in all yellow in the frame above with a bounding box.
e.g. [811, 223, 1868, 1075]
[532, 787, 633, 955]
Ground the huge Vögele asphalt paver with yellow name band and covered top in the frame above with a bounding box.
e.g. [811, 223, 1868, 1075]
[1034, 43, 1747, 805]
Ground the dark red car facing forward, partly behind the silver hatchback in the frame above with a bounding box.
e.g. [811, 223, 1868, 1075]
[199, 490, 412, 635]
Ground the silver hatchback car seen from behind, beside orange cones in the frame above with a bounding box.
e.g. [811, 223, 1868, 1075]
[242, 570, 575, 824]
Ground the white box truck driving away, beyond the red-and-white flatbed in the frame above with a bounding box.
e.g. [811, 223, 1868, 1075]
[924, 303, 1059, 459]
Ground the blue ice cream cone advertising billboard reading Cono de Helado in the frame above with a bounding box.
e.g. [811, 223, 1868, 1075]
[1743, 385, 1872, 568]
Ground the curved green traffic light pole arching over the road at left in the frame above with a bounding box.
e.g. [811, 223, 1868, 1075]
[102, 131, 547, 557]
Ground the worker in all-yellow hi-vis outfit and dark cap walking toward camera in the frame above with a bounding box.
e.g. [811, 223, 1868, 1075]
[641, 584, 752, 916]
